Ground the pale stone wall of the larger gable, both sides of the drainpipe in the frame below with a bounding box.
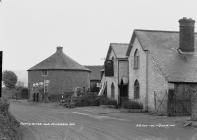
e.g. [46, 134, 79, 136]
[128, 38, 168, 111]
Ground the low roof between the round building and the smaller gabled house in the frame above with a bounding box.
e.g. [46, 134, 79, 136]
[85, 66, 103, 80]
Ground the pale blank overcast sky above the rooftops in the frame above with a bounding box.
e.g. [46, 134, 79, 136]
[0, 0, 197, 70]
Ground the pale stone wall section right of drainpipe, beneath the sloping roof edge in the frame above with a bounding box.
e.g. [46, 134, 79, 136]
[147, 52, 169, 114]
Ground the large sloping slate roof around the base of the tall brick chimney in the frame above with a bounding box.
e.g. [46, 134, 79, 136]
[127, 30, 197, 82]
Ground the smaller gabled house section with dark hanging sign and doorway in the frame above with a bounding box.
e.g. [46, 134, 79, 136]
[104, 43, 129, 104]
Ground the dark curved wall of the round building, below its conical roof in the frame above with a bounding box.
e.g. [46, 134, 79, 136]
[28, 70, 90, 99]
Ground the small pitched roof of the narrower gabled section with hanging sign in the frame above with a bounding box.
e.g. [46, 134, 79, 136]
[106, 43, 129, 59]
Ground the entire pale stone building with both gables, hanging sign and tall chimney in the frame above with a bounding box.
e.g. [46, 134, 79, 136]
[102, 18, 197, 115]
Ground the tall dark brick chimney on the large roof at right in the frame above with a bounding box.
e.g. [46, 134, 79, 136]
[179, 17, 195, 53]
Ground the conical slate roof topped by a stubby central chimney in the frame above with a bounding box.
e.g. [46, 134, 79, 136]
[28, 47, 90, 71]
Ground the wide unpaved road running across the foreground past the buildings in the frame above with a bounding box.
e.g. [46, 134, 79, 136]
[9, 102, 197, 140]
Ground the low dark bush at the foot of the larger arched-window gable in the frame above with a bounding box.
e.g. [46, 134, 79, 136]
[122, 100, 143, 109]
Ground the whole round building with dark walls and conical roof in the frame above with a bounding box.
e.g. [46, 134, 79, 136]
[28, 47, 91, 101]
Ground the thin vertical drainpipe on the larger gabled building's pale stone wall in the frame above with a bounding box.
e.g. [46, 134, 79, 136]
[145, 50, 149, 112]
